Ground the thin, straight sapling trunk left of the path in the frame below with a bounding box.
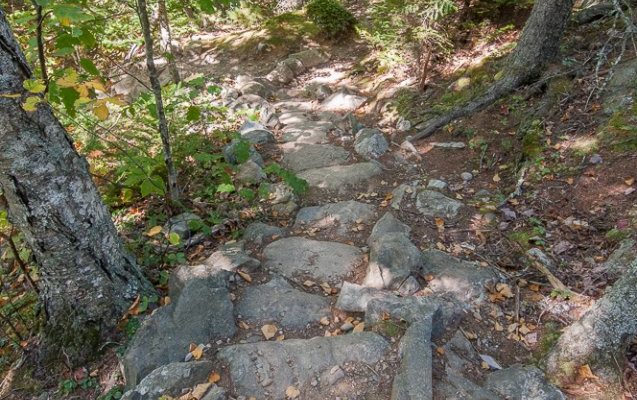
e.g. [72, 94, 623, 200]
[137, 0, 180, 202]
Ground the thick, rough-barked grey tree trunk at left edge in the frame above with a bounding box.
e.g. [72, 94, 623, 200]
[0, 10, 153, 365]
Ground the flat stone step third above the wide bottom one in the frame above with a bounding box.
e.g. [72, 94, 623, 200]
[294, 200, 375, 235]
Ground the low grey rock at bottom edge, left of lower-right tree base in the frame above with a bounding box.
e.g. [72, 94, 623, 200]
[485, 365, 566, 400]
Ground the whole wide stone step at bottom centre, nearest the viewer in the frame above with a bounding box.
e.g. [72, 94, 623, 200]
[217, 332, 389, 399]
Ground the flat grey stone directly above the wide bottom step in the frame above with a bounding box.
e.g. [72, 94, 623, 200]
[235, 277, 330, 329]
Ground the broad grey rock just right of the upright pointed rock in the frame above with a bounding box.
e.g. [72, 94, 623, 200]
[422, 250, 498, 302]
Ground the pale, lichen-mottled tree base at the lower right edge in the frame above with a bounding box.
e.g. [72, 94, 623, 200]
[546, 258, 637, 390]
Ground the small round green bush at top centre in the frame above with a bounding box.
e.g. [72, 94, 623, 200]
[305, 0, 356, 38]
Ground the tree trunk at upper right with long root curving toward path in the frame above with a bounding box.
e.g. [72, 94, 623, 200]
[409, 0, 574, 141]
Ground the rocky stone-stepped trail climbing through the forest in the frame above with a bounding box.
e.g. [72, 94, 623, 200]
[123, 49, 565, 400]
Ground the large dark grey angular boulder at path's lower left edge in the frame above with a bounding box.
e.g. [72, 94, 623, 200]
[122, 266, 236, 388]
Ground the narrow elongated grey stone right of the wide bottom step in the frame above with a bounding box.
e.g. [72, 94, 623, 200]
[391, 313, 433, 400]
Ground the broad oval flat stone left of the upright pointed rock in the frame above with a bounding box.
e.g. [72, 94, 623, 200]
[263, 237, 364, 282]
